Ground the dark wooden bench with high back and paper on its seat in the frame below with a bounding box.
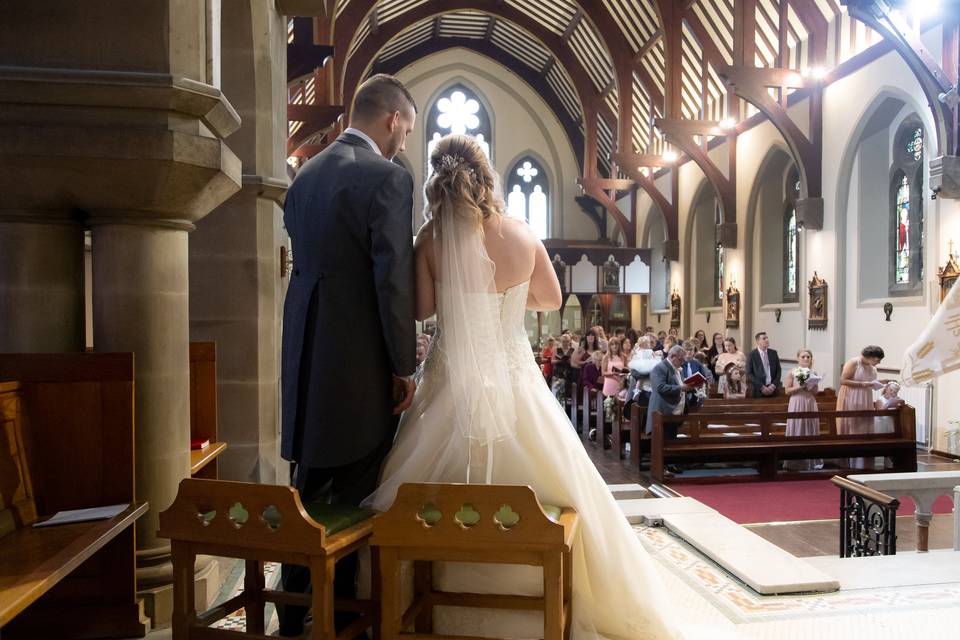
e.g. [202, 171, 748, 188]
[0, 353, 149, 640]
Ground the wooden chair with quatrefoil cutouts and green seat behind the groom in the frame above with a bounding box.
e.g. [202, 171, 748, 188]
[159, 478, 379, 640]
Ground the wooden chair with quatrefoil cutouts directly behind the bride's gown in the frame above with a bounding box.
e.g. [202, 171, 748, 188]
[371, 484, 578, 640]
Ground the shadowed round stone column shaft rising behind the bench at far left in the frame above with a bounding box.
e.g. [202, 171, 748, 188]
[0, 214, 84, 353]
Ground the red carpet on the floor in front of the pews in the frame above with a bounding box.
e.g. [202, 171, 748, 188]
[670, 480, 953, 524]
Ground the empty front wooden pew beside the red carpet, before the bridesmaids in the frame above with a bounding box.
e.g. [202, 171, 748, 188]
[650, 405, 917, 482]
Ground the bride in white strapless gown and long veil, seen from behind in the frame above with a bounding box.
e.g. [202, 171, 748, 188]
[364, 135, 675, 640]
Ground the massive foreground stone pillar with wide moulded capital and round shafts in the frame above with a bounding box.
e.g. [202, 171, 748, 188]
[0, 0, 244, 625]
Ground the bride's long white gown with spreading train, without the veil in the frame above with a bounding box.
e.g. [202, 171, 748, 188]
[365, 282, 676, 640]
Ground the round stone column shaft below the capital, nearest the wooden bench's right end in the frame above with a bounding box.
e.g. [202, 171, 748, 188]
[92, 218, 193, 550]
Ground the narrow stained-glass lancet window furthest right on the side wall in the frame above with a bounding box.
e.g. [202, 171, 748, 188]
[889, 118, 924, 295]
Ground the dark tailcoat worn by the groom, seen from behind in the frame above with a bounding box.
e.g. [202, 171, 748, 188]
[281, 134, 416, 467]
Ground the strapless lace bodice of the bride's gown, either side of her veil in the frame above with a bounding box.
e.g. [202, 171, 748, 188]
[423, 280, 541, 378]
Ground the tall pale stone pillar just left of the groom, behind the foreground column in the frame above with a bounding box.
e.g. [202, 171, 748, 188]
[190, 2, 289, 484]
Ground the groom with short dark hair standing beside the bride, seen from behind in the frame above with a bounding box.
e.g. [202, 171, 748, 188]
[278, 74, 417, 637]
